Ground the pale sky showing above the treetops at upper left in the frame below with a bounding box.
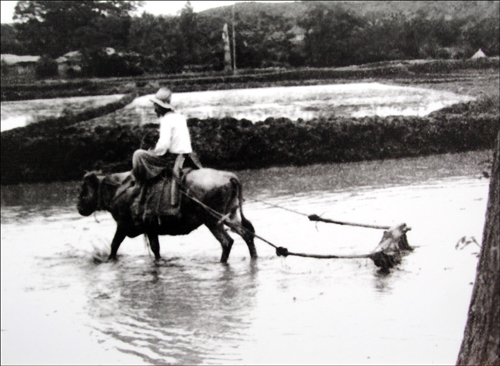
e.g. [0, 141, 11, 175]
[1, 0, 282, 23]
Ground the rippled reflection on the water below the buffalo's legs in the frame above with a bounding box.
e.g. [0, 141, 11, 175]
[82, 259, 257, 364]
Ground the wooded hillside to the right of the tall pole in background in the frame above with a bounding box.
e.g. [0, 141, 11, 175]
[199, 1, 500, 68]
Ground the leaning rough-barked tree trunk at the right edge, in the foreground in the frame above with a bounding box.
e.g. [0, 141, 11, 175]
[457, 131, 500, 365]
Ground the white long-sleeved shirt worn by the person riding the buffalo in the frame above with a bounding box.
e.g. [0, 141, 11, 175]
[154, 112, 193, 155]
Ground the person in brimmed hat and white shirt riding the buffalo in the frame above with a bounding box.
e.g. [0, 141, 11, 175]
[132, 88, 201, 212]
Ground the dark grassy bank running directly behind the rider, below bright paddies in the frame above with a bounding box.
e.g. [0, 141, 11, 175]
[1, 96, 499, 184]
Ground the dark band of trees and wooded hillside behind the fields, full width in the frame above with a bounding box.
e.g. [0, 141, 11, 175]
[1, 1, 499, 76]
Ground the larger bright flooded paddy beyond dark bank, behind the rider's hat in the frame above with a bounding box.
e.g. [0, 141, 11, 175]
[130, 83, 473, 122]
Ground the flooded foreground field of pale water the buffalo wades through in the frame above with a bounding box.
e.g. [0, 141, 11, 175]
[1, 152, 490, 364]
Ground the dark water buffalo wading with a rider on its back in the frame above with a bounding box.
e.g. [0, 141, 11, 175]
[77, 168, 257, 263]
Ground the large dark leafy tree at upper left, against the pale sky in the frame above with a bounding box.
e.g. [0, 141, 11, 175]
[14, 1, 142, 57]
